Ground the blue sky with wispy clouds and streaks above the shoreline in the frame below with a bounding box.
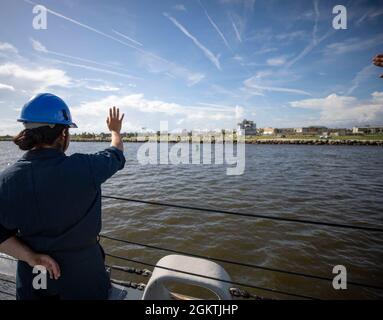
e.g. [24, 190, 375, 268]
[0, 0, 383, 134]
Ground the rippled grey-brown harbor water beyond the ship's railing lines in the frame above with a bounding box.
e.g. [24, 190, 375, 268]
[0, 142, 383, 299]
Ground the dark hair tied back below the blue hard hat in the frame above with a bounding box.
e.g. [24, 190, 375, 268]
[13, 124, 68, 150]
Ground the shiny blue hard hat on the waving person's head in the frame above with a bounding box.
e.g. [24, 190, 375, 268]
[17, 93, 77, 128]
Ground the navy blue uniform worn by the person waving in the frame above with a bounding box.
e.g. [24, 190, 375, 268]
[0, 147, 125, 299]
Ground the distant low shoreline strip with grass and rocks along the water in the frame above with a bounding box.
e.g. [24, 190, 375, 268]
[0, 137, 383, 146]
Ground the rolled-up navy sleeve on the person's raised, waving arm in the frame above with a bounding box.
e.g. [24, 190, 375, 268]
[89, 147, 125, 185]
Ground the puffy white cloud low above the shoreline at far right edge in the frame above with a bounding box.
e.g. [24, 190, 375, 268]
[290, 92, 383, 125]
